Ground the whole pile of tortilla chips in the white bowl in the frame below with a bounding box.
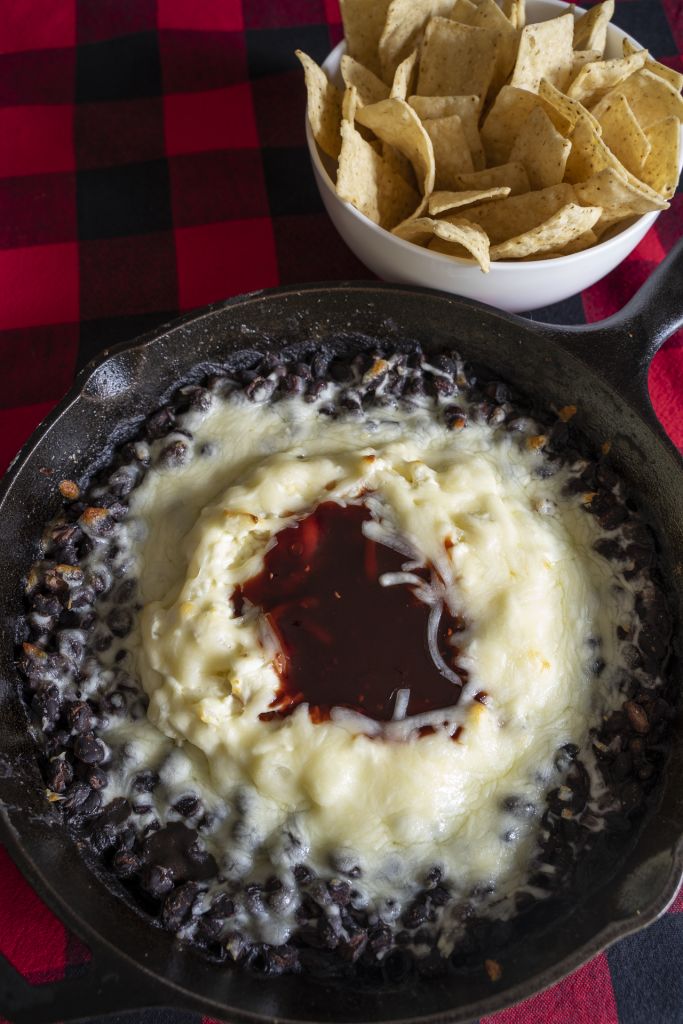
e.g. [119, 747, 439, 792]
[297, 0, 683, 270]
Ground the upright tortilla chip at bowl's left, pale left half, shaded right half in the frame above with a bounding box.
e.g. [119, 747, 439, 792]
[337, 121, 420, 229]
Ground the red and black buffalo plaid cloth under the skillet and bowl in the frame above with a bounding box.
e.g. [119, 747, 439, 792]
[0, 0, 683, 1024]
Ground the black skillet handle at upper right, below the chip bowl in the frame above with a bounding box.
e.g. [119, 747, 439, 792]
[562, 239, 683, 419]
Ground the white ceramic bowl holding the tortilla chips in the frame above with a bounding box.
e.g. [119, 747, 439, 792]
[306, 0, 679, 312]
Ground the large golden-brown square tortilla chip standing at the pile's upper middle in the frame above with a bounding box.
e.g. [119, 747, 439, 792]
[417, 17, 498, 102]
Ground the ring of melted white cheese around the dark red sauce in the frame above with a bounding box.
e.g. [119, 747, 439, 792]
[111, 397, 632, 913]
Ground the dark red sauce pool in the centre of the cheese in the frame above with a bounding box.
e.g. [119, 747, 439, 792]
[234, 502, 462, 721]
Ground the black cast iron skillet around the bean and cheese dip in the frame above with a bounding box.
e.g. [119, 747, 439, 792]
[0, 243, 683, 1024]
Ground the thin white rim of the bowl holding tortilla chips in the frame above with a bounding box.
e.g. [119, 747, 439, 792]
[304, 0, 667, 280]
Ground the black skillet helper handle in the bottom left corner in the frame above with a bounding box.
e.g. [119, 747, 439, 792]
[0, 942, 169, 1024]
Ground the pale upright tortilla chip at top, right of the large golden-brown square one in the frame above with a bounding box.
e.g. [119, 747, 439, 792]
[510, 13, 573, 92]
